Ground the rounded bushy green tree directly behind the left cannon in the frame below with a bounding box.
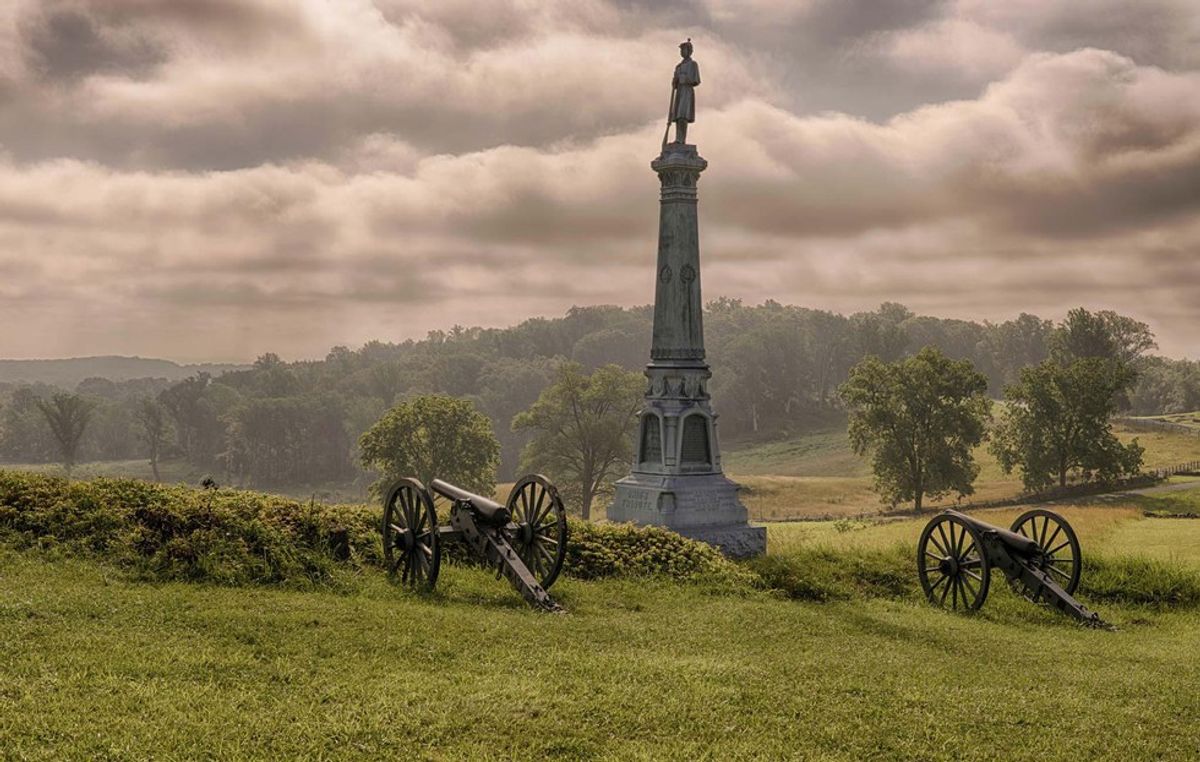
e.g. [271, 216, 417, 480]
[359, 395, 500, 496]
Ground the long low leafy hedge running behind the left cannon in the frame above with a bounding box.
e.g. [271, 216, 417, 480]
[0, 472, 750, 584]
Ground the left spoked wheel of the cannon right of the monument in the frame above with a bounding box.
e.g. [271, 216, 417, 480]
[917, 514, 991, 611]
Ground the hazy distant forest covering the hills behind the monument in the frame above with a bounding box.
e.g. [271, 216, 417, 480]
[0, 299, 1200, 487]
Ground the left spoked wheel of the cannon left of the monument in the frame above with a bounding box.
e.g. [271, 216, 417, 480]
[383, 479, 442, 589]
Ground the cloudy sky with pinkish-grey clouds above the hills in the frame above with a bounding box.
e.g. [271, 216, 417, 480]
[0, 0, 1200, 360]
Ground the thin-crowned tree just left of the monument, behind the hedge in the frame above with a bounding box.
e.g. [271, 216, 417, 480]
[512, 362, 646, 520]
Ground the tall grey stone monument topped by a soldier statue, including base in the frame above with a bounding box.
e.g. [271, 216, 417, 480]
[608, 40, 767, 557]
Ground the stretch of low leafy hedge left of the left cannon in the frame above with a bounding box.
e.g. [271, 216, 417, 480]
[0, 472, 380, 584]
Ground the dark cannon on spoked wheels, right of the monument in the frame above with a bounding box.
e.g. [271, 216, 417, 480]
[917, 509, 1103, 625]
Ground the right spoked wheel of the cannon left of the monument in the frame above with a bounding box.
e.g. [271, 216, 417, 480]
[505, 474, 566, 589]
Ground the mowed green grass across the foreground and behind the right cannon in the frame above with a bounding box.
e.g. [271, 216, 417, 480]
[7, 505, 1200, 760]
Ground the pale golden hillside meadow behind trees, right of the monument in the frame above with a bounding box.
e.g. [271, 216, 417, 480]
[724, 425, 1200, 521]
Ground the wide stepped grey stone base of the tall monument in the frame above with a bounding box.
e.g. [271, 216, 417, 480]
[607, 473, 767, 558]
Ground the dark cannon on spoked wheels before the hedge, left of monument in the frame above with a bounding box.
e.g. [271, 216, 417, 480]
[383, 474, 566, 611]
